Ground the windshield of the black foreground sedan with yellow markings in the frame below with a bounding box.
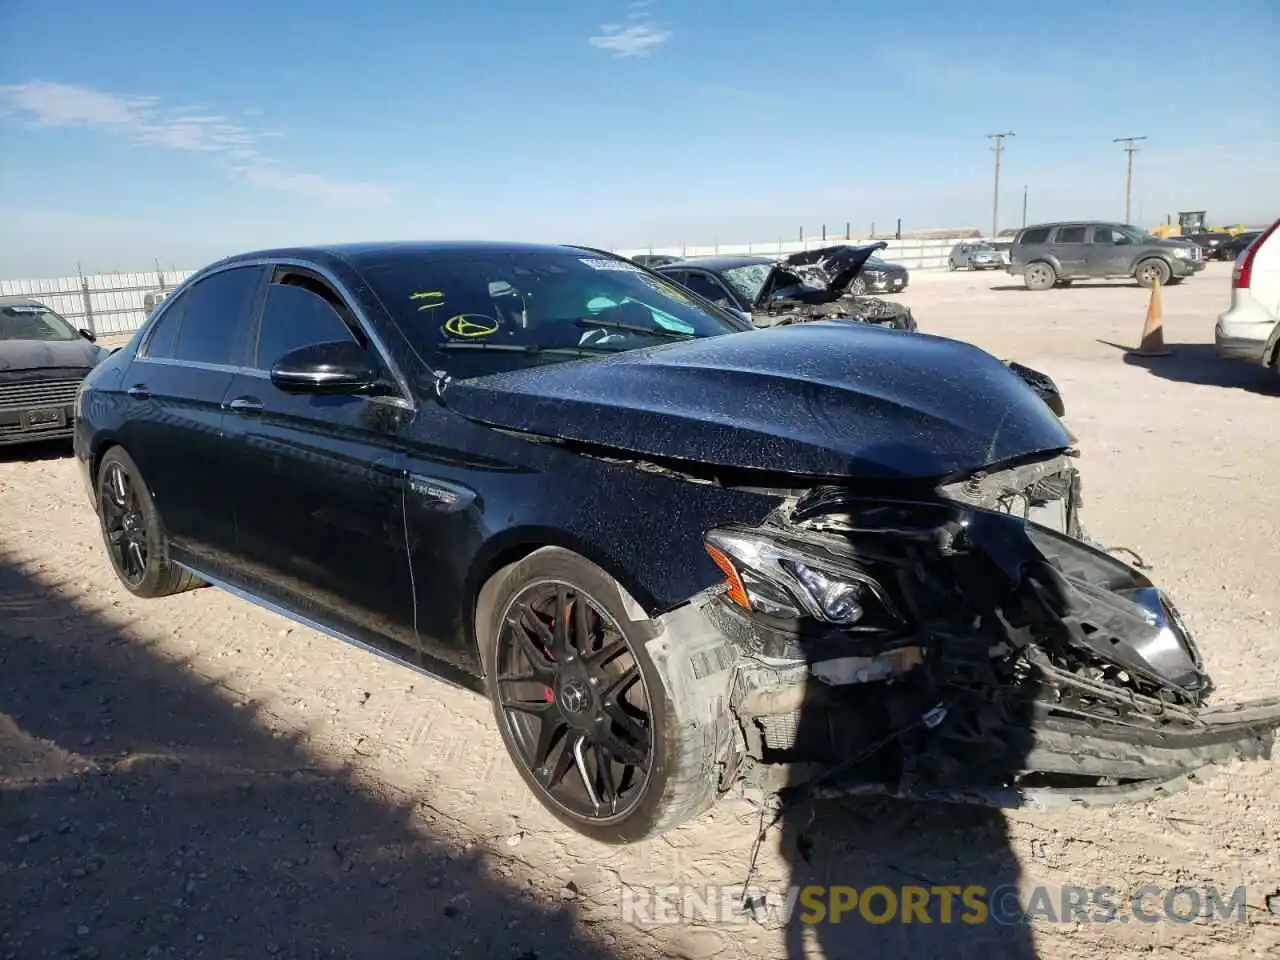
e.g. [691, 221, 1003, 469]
[362, 251, 745, 379]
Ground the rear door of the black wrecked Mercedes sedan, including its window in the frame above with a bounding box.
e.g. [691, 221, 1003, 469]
[120, 266, 265, 563]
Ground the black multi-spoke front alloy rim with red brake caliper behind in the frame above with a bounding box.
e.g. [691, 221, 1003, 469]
[494, 580, 654, 826]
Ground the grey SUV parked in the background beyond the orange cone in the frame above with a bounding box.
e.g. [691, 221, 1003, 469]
[1005, 220, 1204, 291]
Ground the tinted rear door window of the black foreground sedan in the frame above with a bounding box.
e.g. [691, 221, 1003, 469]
[167, 266, 265, 365]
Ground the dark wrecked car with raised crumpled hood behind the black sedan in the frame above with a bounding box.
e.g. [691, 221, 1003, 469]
[653, 241, 916, 330]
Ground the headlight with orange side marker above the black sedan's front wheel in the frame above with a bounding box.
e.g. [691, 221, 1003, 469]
[705, 530, 901, 626]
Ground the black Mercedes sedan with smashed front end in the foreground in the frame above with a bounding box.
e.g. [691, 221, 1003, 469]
[76, 242, 1280, 844]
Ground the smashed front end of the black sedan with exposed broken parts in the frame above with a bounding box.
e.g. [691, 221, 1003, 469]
[686, 483, 1280, 806]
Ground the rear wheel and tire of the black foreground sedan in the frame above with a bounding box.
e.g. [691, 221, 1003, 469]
[96, 447, 204, 599]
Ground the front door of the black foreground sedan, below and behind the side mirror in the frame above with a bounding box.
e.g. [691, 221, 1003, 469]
[227, 266, 416, 645]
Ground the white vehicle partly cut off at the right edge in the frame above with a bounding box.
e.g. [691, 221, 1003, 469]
[1213, 220, 1280, 374]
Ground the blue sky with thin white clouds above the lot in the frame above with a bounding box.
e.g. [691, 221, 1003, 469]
[0, 0, 1280, 279]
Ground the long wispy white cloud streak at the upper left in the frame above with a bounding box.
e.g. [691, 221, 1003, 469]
[0, 81, 392, 207]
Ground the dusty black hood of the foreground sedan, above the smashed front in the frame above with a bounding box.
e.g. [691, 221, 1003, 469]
[443, 320, 1071, 480]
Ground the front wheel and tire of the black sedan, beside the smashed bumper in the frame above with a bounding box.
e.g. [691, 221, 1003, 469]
[476, 548, 722, 844]
